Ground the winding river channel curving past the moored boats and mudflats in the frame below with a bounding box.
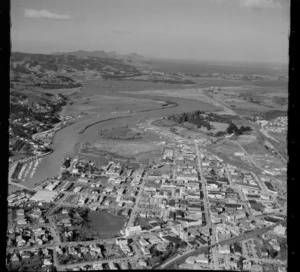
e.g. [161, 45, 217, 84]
[24, 81, 216, 187]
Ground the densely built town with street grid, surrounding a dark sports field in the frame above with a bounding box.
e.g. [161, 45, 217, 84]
[7, 128, 286, 271]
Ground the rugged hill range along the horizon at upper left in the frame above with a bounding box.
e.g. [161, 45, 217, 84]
[10, 50, 147, 74]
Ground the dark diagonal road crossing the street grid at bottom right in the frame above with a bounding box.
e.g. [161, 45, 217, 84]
[156, 224, 277, 269]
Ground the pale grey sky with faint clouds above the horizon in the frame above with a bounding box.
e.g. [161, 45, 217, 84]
[11, 0, 290, 64]
